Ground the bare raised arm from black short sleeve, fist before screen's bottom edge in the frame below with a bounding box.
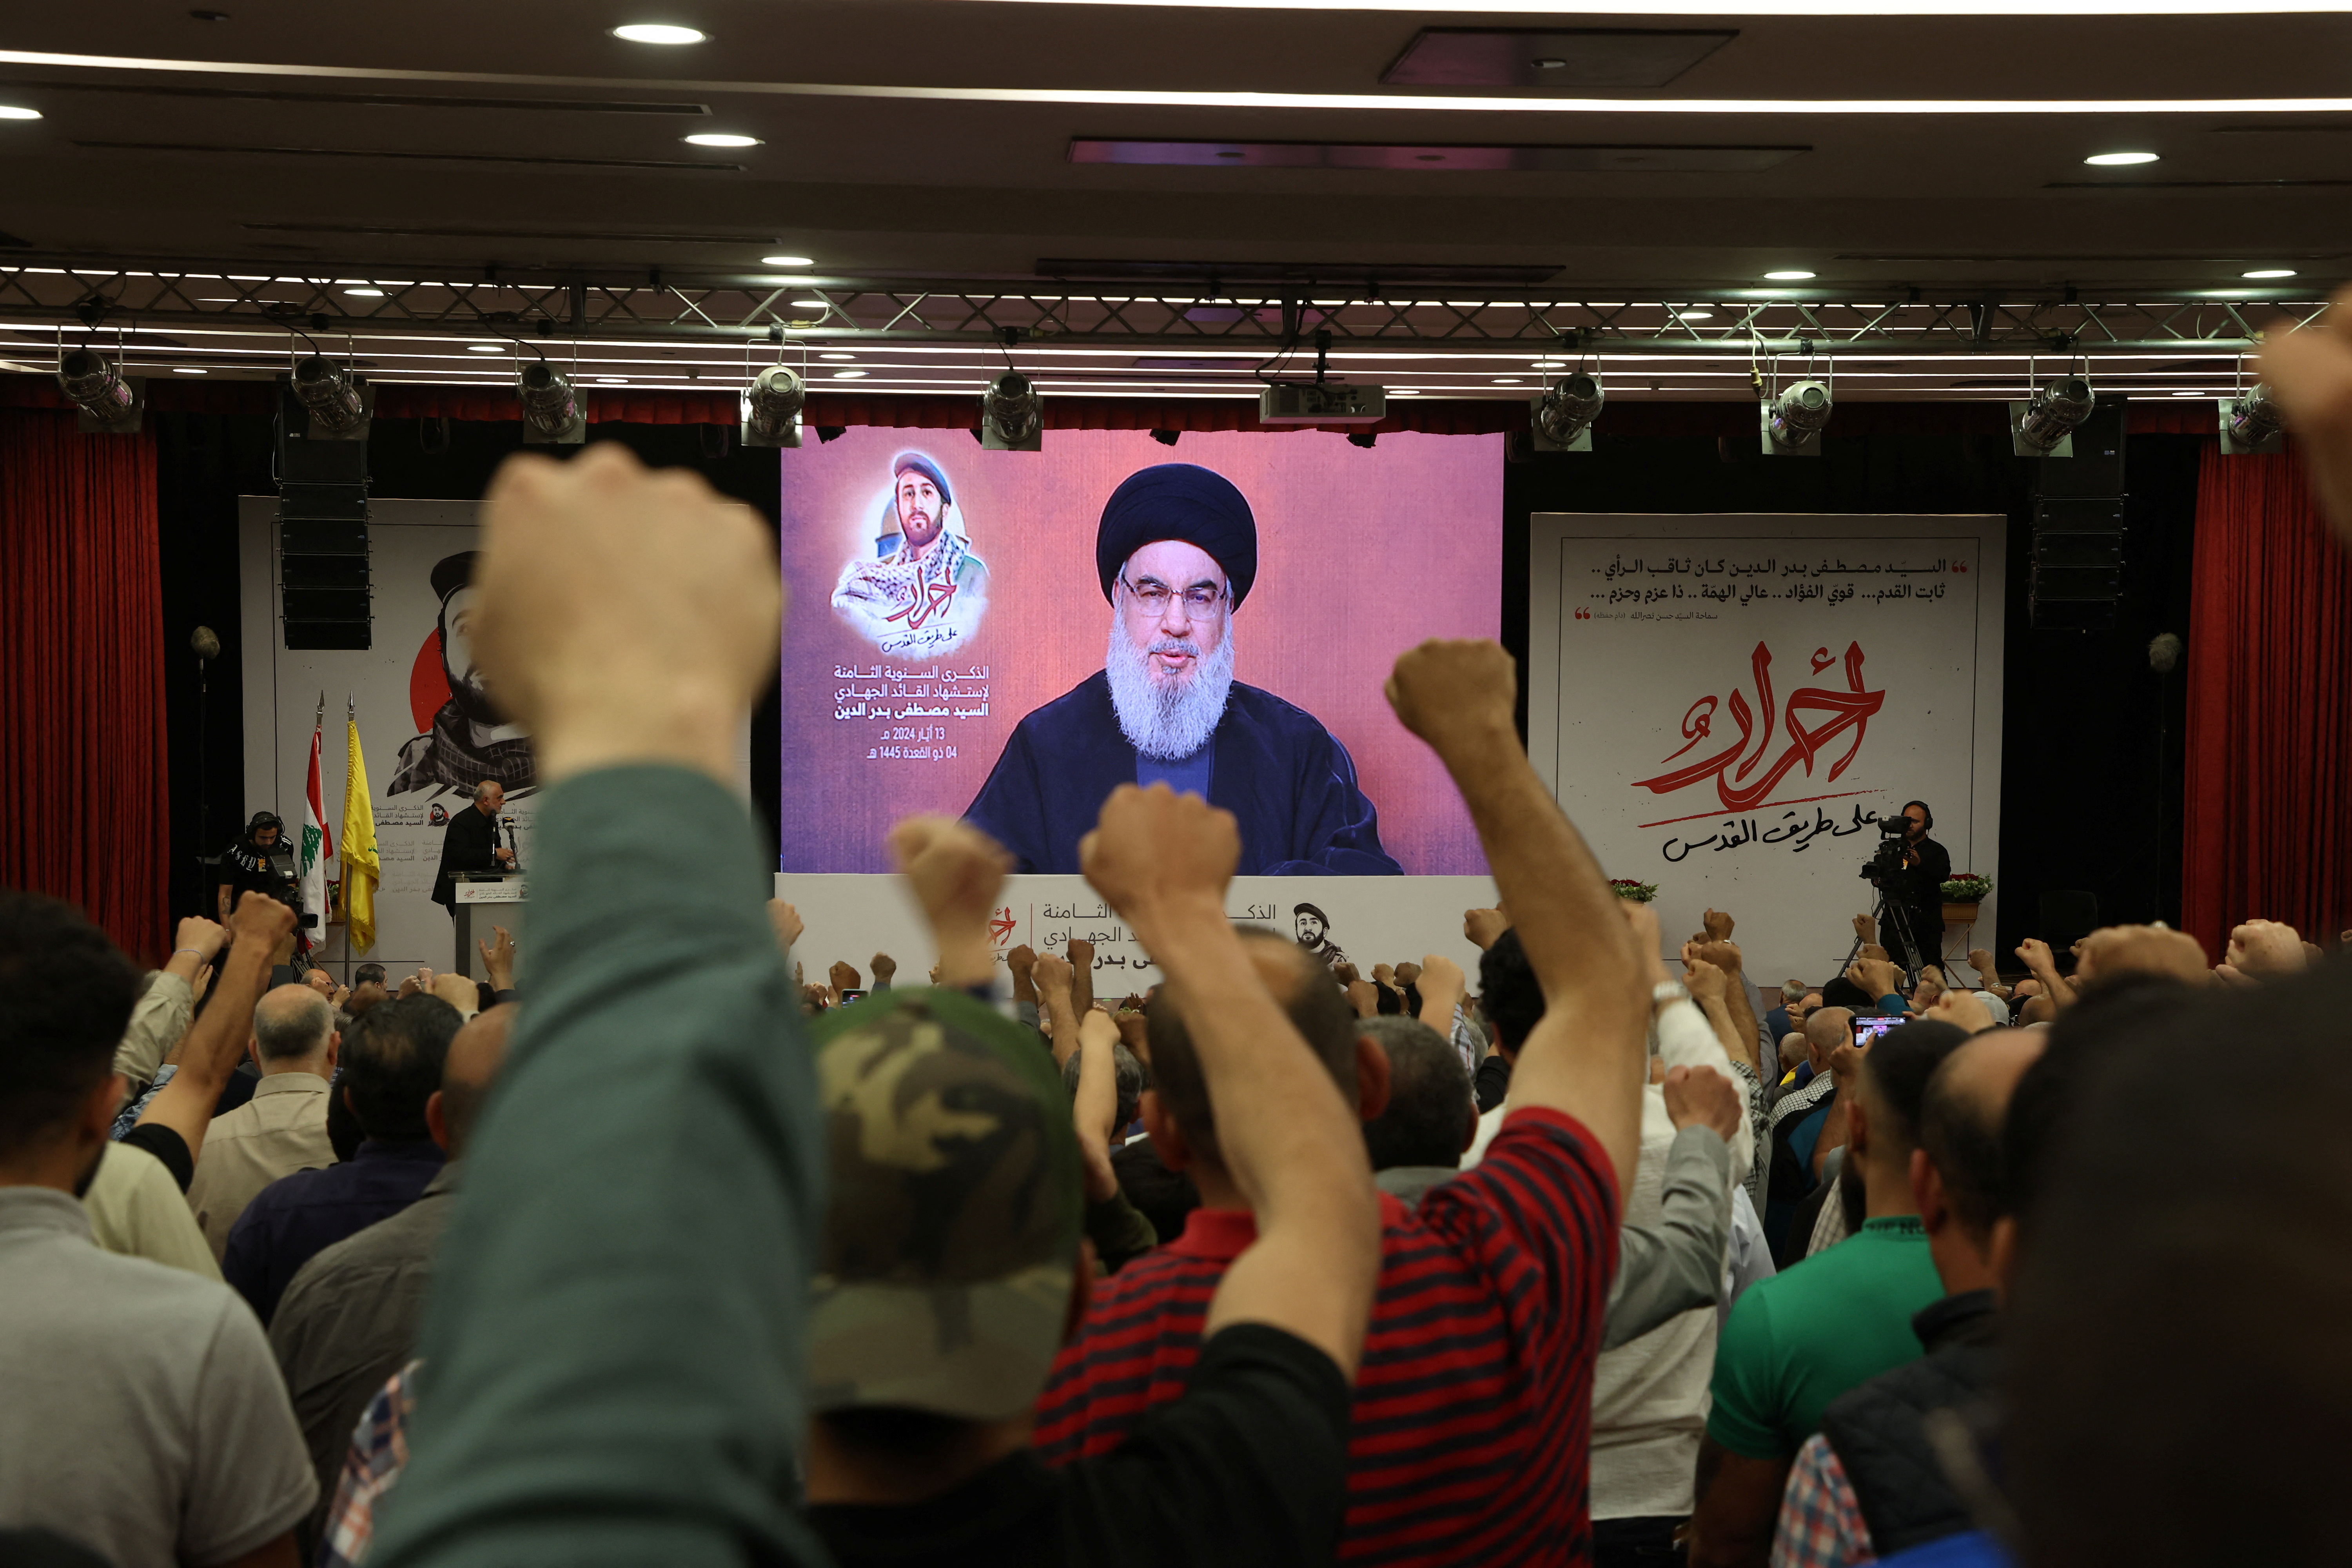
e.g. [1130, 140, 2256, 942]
[1080, 785, 1383, 1382]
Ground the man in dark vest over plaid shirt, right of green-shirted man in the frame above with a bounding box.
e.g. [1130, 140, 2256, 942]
[1773, 1030, 2042, 1568]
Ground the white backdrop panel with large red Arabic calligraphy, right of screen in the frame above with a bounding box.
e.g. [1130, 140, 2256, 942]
[1526, 512, 2006, 983]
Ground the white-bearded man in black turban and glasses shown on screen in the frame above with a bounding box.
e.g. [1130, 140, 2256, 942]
[964, 463, 1402, 877]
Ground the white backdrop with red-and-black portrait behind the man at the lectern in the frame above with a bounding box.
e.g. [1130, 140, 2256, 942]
[239, 496, 750, 976]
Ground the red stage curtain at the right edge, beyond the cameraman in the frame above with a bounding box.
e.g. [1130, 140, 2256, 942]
[2180, 444, 2352, 962]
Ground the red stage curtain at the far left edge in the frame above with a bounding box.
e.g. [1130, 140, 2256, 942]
[0, 409, 172, 964]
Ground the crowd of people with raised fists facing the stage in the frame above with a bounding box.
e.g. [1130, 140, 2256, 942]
[14, 297, 2352, 1568]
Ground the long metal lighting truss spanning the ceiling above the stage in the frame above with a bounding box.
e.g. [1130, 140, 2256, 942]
[0, 256, 2326, 397]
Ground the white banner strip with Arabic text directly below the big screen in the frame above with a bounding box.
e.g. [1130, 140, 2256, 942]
[776, 872, 1494, 999]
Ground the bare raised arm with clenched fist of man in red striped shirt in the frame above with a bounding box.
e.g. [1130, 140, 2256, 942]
[1388, 642, 1649, 1192]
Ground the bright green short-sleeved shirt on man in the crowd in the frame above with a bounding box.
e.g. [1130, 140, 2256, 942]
[1708, 1199, 1943, 1460]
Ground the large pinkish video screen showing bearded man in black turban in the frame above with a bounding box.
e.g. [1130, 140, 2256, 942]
[779, 428, 1503, 877]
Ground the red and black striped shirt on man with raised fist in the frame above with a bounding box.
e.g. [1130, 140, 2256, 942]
[1035, 1110, 1618, 1566]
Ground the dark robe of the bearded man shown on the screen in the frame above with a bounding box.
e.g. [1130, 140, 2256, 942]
[964, 670, 1404, 877]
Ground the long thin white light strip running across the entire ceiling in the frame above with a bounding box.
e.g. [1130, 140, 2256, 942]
[0, 49, 2352, 115]
